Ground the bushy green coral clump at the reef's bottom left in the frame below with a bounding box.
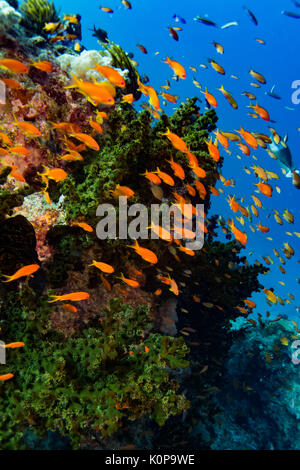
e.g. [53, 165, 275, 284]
[0, 296, 188, 449]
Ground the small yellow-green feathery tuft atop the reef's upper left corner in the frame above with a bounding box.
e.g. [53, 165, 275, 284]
[20, 0, 59, 34]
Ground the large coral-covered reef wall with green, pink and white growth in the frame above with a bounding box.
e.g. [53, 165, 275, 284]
[0, 7, 265, 449]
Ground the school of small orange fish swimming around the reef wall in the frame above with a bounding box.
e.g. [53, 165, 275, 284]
[0, 0, 300, 381]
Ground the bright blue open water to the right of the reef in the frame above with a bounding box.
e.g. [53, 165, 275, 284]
[60, 0, 300, 318]
